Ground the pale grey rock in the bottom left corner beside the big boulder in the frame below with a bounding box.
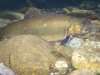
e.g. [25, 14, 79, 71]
[0, 63, 17, 75]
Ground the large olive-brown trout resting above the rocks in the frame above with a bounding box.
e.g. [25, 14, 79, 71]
[0, 7, 91, 41]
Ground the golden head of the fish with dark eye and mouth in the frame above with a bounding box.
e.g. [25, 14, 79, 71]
[66, 19, 92, 38]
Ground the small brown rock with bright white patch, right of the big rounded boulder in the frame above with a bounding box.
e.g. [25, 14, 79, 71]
[49, 57, 71, 75]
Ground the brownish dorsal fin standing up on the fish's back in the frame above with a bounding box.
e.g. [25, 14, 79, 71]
[25, 7, 41, 18]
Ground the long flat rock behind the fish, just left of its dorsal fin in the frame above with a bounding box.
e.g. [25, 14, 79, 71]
[0, 12, 24, 20]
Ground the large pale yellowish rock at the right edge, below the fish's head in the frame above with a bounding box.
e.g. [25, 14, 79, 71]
[72, 40, 100, 74]
